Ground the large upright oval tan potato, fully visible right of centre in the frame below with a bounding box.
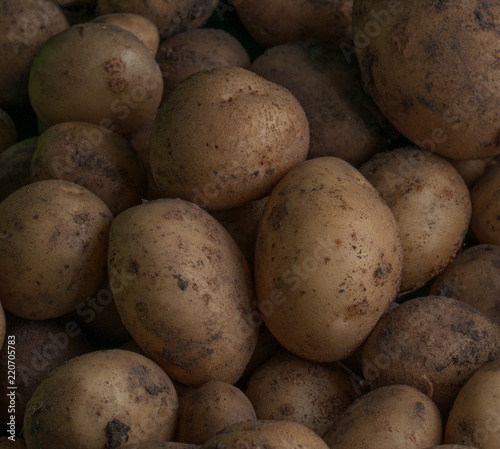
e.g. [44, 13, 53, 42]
[255, 157, 403, 362]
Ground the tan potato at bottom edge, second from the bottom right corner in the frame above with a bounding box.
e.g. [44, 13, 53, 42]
[323, 385, 442, 449]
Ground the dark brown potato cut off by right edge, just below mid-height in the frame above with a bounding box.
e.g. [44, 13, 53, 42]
[430, 245, 500, 326]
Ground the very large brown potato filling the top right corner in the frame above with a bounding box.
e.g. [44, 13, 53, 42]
[354, 0, 500, 159]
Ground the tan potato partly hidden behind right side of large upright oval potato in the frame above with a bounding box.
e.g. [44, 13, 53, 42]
[359, 147, 471, 292]
